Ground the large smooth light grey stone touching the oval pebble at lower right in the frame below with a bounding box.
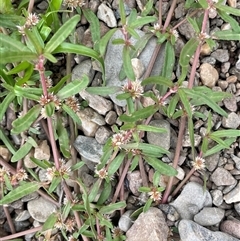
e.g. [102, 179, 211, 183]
[170, 182, 212, 220]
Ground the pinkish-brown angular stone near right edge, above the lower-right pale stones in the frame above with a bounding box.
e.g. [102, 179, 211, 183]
[211, 167, 236, 186]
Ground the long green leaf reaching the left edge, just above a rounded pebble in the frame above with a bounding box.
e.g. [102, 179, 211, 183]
[0, 182, 41, 205]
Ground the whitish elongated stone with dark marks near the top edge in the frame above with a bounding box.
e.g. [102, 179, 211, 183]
[97, 3, 117, 28]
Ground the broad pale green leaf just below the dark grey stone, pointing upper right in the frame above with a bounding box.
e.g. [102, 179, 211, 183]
[57, 75, 89, 100]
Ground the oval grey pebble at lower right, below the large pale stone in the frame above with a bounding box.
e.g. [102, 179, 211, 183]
[194, 207, 225, 226]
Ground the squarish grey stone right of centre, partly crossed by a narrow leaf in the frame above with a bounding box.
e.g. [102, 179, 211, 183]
[147, 120, 171, 150]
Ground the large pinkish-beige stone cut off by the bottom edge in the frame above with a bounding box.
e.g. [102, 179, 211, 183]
[126, 207, 169, 241]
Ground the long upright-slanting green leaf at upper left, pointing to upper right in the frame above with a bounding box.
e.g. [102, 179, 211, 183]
[44, 15, 80, 53]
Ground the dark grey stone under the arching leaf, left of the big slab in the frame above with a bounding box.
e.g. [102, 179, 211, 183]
[72, 59, 95, 82]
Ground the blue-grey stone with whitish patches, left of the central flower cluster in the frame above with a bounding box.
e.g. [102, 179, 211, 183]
[74, 136, 103, 163]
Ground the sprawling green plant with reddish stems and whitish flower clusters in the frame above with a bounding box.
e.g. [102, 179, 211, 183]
[0, 0, 240, 241]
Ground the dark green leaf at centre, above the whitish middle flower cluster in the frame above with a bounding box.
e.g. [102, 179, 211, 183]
[119, 106, 158, 122]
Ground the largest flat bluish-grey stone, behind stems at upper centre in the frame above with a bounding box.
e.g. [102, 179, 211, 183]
[105, 30, 164, 106]
